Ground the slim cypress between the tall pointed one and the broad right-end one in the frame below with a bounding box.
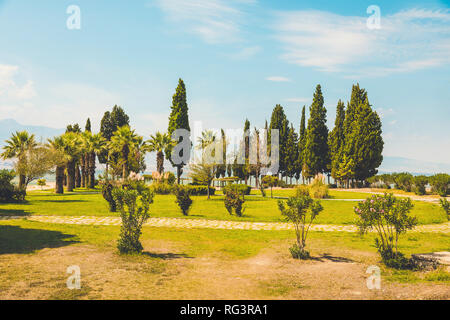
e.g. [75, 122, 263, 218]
[328, 100, 345, 179]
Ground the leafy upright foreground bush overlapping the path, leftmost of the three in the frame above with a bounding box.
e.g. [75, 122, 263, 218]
[112, 184, 154, 253]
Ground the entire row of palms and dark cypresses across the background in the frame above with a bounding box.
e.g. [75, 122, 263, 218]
[2, 79, 383, 193]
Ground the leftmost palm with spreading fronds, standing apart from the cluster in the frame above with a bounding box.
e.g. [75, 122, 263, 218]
[1, 131, 37, 189]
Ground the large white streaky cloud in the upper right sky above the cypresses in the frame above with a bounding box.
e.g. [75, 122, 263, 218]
[274, 9, 450, 77]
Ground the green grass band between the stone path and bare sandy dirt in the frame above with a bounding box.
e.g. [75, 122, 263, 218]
[0, 220, 450, 258]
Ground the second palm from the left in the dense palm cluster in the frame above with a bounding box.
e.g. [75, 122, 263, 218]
[62, 132, 82, 192]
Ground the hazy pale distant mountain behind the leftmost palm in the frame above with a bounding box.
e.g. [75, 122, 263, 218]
[0, 119, 65, 146]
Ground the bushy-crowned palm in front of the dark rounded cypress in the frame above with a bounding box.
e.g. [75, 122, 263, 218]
[108, 126, 139, 179]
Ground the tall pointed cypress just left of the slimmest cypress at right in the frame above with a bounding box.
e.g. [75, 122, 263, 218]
[304, 85, 329, 176]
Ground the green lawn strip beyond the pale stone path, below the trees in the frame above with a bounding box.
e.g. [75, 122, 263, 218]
[0, 190, 447, 224]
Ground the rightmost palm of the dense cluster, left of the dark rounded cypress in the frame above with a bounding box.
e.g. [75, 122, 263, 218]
[83, 131, 106, 189]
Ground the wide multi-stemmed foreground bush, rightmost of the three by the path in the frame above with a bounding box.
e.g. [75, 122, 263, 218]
[354, 193, 417, 269]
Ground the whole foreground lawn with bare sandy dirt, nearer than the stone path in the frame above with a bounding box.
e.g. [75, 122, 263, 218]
[0, 220, 450, 299]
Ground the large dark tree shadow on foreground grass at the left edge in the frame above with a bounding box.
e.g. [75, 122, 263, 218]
[0, 225, 79, 255]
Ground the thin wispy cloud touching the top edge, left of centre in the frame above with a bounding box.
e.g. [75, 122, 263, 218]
[154, 0, 254, 43]
